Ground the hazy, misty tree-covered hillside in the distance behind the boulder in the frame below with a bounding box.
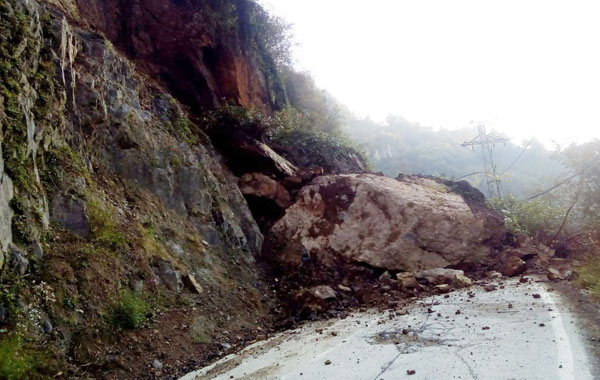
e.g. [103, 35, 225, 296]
[345, 115, 564, 197]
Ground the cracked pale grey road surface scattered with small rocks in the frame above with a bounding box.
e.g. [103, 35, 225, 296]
[182, 280, 600, 380]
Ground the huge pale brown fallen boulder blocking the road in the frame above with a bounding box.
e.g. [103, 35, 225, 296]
[266, 174, 504, 271]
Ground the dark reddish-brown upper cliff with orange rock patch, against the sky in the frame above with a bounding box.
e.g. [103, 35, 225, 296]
[47, 0, 285, 112]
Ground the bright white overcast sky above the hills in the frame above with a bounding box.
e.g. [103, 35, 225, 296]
[262, 0, 600, 143]
